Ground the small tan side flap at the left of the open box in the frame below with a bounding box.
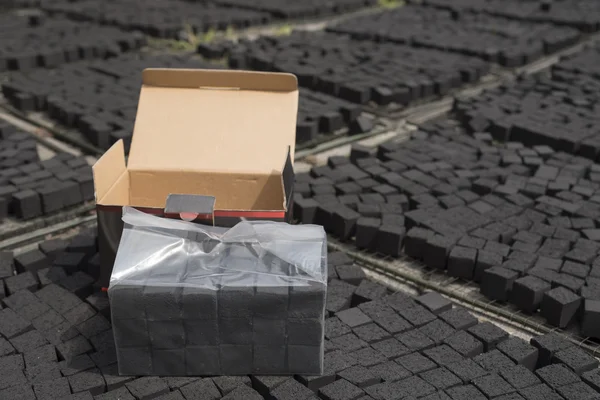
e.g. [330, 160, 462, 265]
[92, 140, 127, 204]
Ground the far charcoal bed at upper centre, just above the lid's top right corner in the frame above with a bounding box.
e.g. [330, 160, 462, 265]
[198, 32, 489, 105]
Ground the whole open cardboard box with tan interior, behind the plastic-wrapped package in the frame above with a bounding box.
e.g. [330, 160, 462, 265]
[93, 69, 298, 287]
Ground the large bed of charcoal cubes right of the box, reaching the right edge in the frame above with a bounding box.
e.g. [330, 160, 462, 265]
[295, 120, 600, 337]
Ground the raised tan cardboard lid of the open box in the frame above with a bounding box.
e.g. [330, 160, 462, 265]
[128, 69, 298, 174]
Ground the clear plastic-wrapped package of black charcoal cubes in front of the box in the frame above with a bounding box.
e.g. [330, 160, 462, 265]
[108, 207, 327, 376]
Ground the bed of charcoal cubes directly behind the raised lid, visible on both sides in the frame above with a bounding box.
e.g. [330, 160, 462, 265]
[2, 54, 372, 149]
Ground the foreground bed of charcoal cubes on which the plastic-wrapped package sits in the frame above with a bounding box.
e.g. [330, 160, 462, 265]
[0, 227, 600, 400]
